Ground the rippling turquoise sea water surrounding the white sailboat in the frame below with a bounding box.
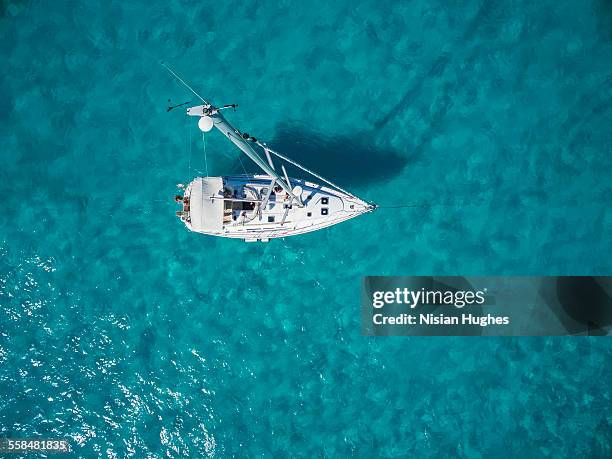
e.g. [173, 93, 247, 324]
[0, 0, 612, 458]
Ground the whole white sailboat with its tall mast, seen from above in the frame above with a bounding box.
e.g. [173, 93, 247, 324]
[167, 64, 377, 242]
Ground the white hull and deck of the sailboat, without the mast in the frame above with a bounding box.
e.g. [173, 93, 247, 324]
[177, 175, 375, 242]
